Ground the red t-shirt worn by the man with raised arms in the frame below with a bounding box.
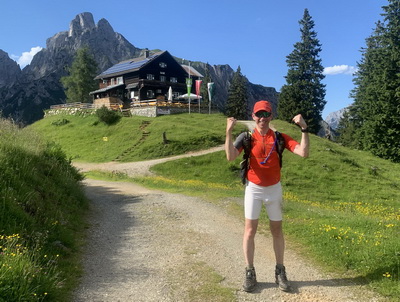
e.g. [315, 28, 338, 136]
[234, 129, 299, 187]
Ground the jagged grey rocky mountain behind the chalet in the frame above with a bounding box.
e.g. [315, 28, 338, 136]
[0, 12, 278, 124]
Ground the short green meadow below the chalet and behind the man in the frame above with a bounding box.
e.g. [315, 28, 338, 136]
[10, 114, 400, 301]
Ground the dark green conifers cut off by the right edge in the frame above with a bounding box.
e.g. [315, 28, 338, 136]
[349, 0, 400, 162]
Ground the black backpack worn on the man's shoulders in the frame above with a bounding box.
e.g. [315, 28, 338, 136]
[240, 131, 285, 184]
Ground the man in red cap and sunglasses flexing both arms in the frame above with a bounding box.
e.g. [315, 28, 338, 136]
[225, 101, 309, 292]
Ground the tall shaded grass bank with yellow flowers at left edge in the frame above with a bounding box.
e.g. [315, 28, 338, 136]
[0, 120, 87, 301]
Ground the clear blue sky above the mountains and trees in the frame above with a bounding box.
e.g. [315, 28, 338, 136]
[0, 0, 388, 118]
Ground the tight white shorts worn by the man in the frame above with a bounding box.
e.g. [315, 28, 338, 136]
[244, 181, 282, 221]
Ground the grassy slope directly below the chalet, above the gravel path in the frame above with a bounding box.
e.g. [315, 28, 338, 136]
[30, 113, 242, 162]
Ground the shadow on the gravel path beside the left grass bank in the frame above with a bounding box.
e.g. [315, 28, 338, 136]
[73, 183, 152, 302]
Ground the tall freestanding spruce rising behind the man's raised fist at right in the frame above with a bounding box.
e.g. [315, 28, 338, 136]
[278, 9, 326, 133]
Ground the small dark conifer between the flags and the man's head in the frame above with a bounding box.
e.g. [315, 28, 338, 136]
[225, 66, 249, 120]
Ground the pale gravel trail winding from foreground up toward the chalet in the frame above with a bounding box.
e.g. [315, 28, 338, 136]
[73, 123, 380, 302]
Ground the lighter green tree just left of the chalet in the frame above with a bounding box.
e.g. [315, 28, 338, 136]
[61, 47, 98, 103]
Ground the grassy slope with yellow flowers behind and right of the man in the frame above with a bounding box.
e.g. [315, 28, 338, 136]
[137, 120, 400, 300]
